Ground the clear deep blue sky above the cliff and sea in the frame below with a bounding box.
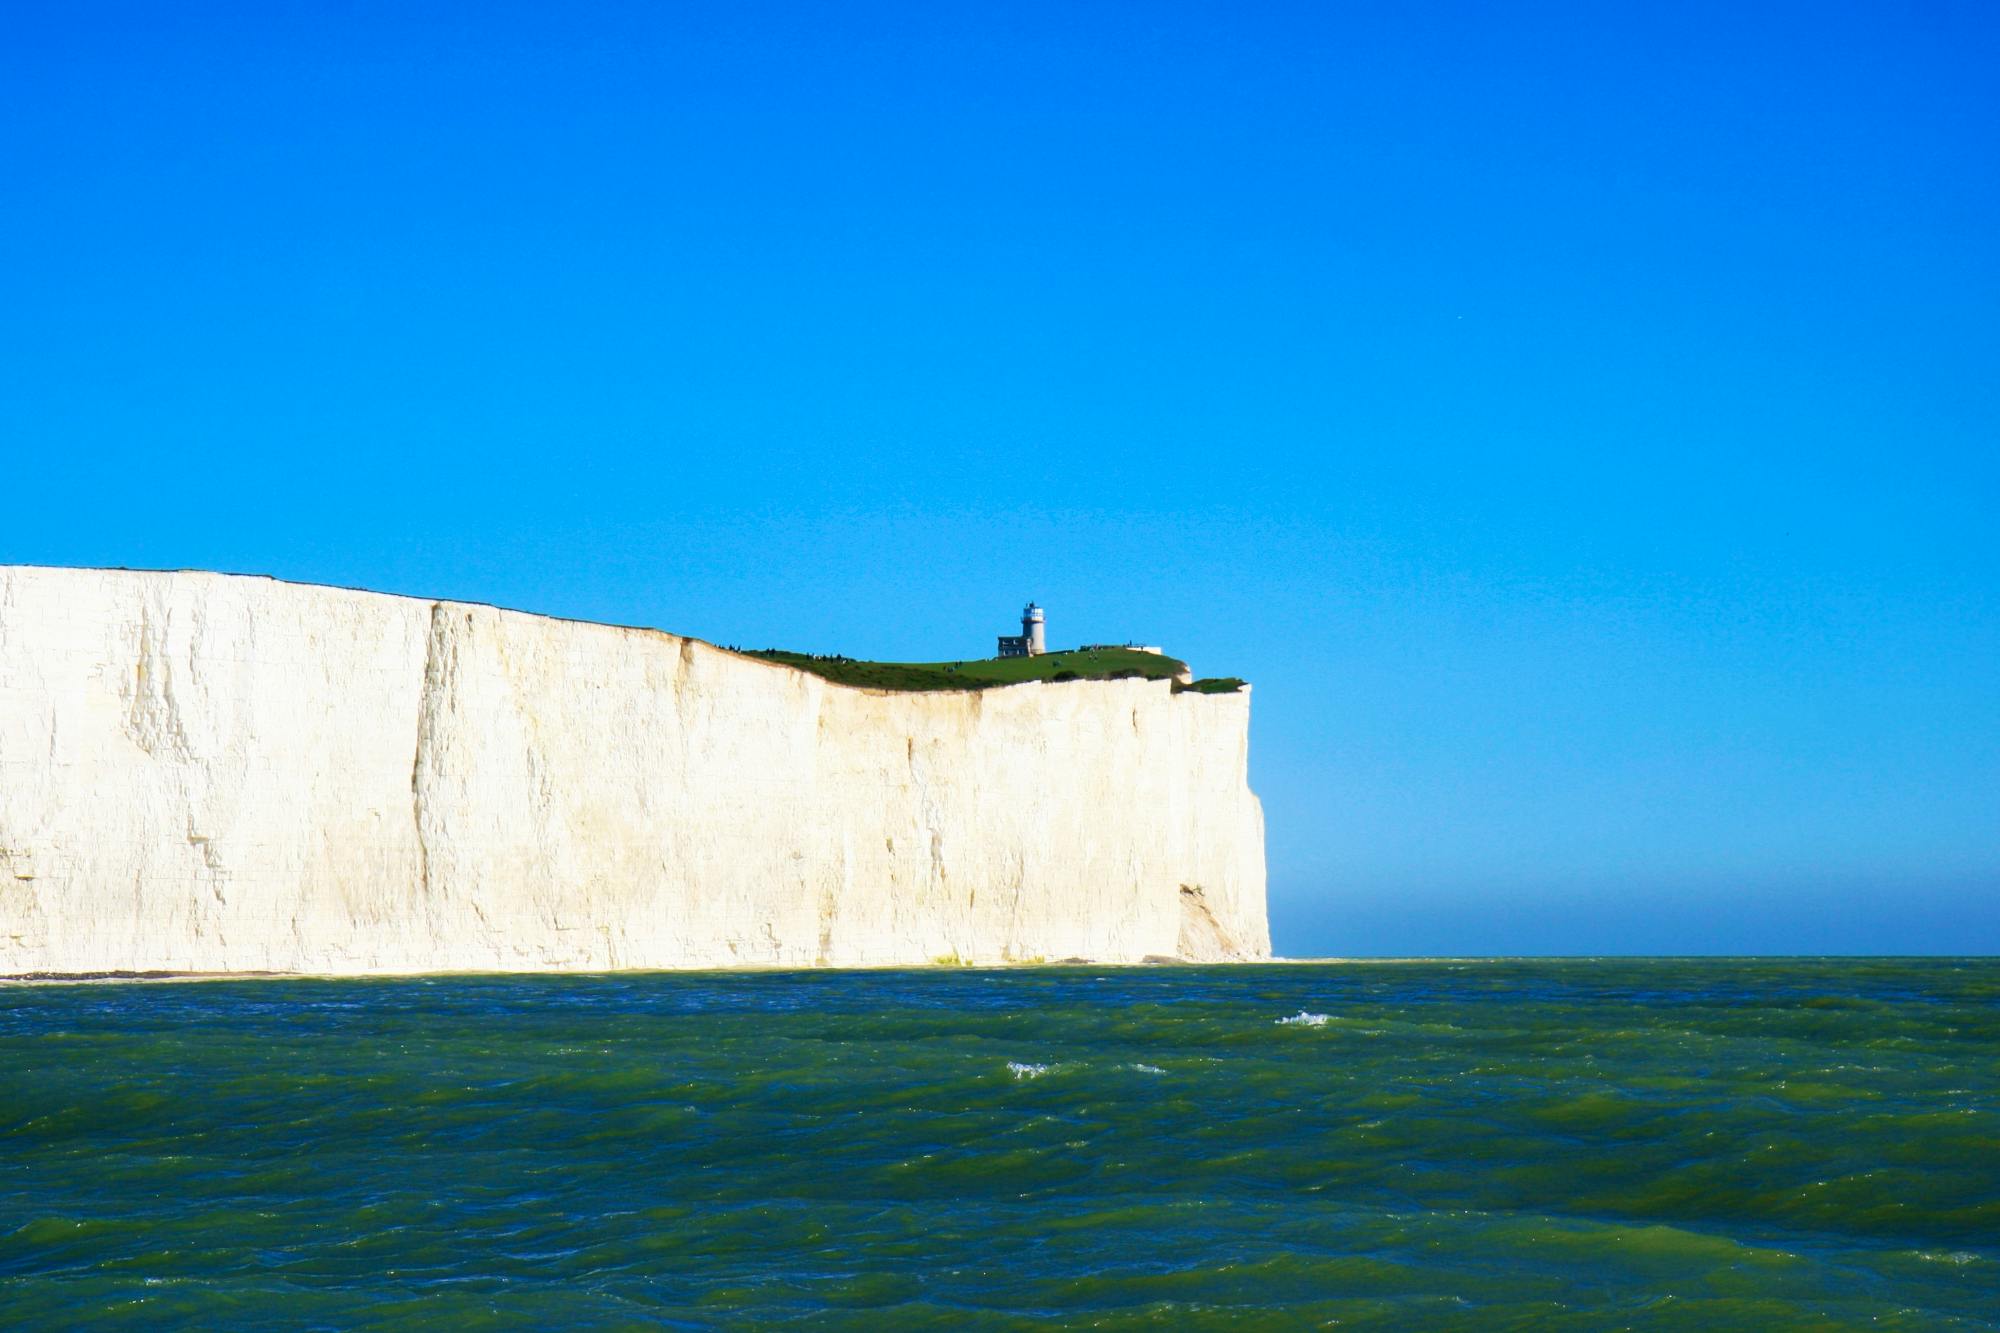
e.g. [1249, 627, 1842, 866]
[0, 0, 2000, 955]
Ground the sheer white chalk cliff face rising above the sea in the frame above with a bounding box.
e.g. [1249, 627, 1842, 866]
[0, 568, 1270, 975]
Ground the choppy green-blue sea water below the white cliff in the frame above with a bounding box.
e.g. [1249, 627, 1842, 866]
[0, 961, 2000, 1331]
